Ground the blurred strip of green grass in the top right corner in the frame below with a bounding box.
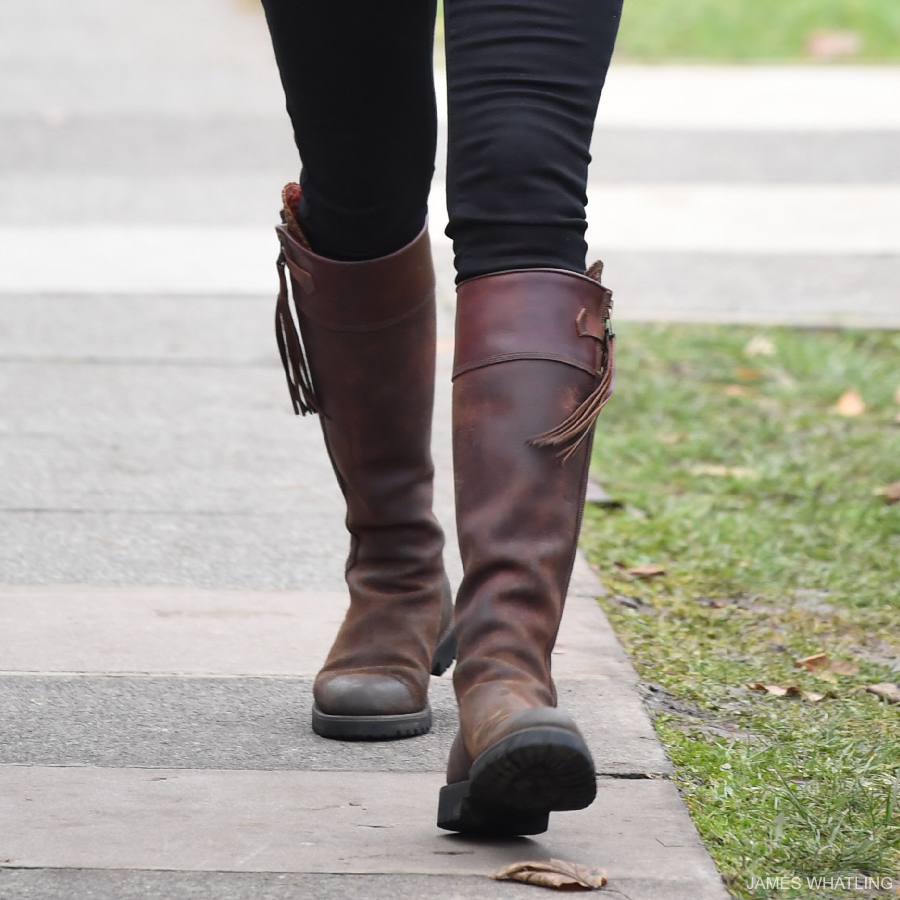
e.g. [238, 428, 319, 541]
[617, 0, 900, 62]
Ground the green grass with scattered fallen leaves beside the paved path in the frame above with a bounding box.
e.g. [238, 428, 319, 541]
[582, 323, 900, 898]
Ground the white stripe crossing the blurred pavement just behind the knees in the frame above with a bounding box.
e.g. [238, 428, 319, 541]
[0, 183, 900, 295]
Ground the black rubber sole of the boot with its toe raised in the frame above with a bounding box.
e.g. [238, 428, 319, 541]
[437, 727, 597, 836]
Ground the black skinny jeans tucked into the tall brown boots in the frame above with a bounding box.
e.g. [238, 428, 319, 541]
[263, 0, 622, 281]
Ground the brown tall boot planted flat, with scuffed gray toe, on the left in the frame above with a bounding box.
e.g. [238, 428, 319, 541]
[276, 185, 456, 740]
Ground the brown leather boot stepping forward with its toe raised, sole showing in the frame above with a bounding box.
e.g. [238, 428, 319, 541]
[438, 264, 614, 835]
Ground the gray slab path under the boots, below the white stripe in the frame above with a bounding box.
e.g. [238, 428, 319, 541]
[0, 280, 724, 900]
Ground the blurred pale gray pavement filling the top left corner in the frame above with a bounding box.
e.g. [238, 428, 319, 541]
[0, 0, 284, 121]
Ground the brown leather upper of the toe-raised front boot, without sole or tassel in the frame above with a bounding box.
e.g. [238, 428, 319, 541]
[447, 270, 609, 783]
